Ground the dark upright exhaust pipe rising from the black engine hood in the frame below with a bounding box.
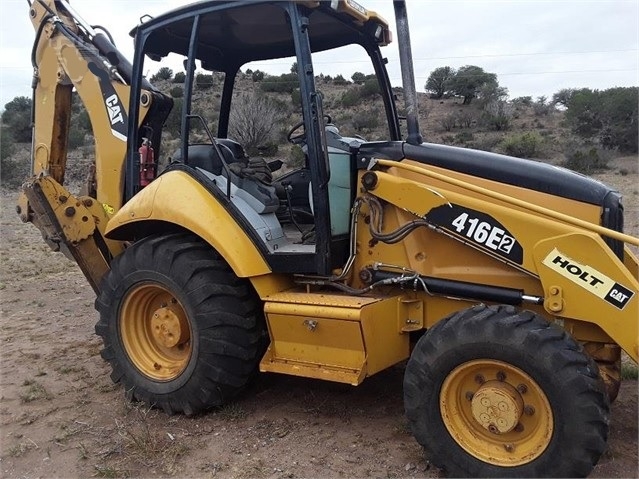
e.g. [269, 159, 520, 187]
[393, 0, 423, 145]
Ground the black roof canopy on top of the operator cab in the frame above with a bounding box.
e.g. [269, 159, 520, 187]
[136, 0, 390, 71]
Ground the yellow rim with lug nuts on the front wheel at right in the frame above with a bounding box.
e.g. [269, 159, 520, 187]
[439, 359, 553, 467]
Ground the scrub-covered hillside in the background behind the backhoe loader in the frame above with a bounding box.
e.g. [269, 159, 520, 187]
[2, 70, 637, 188]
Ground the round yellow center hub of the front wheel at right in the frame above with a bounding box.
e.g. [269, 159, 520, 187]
[471, 381, 524, 434]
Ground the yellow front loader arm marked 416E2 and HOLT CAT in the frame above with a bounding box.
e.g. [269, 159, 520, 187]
[361, 160, 639, 361]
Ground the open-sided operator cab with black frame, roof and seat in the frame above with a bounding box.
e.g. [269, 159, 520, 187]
[127, 0, 401, 275]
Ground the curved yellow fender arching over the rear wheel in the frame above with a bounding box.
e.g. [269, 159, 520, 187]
[105, 171, 271, 278]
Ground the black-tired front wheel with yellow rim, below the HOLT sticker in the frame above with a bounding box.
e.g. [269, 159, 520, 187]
[404, 305, 609, 477]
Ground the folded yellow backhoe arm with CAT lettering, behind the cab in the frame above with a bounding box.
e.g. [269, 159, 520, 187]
[18, 0, 171, 291]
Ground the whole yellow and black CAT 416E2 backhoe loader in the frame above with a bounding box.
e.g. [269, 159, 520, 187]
[17, 0, 639, 477]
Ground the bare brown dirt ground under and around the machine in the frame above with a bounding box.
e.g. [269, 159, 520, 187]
[0, 158, 639, 478]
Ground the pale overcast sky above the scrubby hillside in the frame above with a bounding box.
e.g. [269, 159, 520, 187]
[0, 0, 639, 109]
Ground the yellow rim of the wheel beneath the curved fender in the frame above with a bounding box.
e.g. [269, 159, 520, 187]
[119, 283, 192, 381]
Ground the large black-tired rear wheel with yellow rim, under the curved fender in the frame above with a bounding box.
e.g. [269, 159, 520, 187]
[95, 234, 268, 415]
